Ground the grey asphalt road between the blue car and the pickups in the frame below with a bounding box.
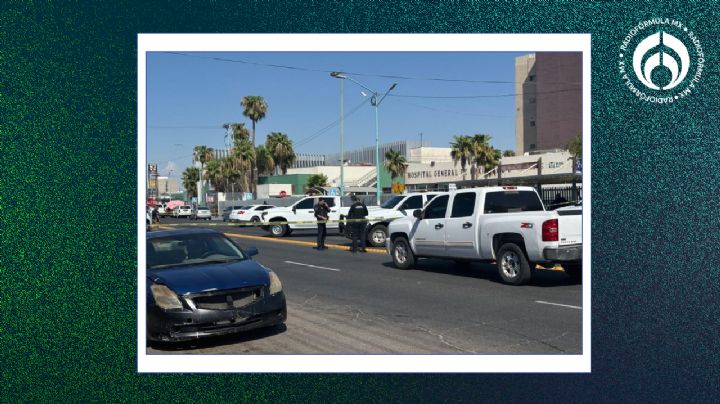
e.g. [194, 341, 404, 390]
[147, 219, 582, 354]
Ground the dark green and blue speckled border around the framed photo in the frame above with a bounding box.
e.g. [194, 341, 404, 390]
[0, 0, 720, 402]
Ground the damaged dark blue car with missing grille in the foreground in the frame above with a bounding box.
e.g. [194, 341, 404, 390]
[146, 229, 287, 341]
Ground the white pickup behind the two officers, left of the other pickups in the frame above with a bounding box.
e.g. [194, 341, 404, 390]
[260, 196, 349, 237]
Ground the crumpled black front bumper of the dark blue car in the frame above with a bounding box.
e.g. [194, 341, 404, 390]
[146, 292, 287, 341]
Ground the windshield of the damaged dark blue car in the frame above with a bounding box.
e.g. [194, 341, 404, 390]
[146, 234, 247, 269]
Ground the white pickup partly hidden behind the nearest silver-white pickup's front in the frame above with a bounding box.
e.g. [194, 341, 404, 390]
[340, 192, 440, 247]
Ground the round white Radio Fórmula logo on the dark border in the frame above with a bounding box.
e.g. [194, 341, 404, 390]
[619, 18, 705, 104]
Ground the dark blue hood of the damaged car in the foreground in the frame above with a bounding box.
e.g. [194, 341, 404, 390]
[147, 260, 270, 295]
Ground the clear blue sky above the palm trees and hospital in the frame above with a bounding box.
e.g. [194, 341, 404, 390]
[147, 52, 530, 178]
